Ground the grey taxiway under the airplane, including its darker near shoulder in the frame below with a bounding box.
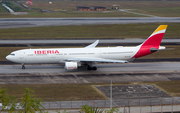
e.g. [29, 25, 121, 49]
[0, 62, 180, 84]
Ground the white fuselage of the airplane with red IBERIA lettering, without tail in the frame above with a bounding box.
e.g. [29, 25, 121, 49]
[6, 46, 140, 63]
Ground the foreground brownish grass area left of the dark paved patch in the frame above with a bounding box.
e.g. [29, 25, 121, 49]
[0, 84, 106, 100]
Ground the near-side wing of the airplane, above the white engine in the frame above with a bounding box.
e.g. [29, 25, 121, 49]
[65, 58, 127, 63]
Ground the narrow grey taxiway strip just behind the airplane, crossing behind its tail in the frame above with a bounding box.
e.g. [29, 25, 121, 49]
[0, 37, 180, 46]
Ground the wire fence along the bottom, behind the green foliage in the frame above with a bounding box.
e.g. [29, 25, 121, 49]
[0, 97, 180, 113]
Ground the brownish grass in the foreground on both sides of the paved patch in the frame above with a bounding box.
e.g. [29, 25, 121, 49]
[0, 81, 180, 101]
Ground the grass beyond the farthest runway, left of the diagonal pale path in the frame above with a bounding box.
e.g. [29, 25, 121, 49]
[0, 10, 142, 18]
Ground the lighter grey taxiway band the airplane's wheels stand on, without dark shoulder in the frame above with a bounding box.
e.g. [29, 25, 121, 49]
[0, 62, 180, 74]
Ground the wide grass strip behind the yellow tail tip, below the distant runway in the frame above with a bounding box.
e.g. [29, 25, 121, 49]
[0, 23, 180, 39]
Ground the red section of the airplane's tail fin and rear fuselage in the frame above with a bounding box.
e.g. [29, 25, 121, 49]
[132, 33, 164, 58]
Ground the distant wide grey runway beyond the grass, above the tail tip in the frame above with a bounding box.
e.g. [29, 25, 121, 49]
[0, 17, 180, 29]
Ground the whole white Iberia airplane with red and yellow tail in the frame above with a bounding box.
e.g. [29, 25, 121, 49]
[6, 25, 167, 70]
